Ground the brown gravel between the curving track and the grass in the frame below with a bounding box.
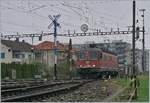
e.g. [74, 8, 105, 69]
[45, 80, 121, 102]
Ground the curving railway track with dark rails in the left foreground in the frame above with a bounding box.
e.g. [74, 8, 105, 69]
[1, 80, 92, 102]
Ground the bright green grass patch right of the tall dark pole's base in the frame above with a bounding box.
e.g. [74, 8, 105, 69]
[137, 75, 149, 102]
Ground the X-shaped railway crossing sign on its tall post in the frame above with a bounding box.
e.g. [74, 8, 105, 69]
[48, 15, 60, 80]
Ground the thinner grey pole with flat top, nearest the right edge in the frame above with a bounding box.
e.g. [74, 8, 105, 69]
[139, 9, 145, 72]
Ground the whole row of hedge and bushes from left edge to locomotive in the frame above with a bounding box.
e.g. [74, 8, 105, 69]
[1, 60, 76, 80]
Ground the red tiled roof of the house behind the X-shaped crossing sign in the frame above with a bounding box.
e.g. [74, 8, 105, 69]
[34, 41, 66, 51]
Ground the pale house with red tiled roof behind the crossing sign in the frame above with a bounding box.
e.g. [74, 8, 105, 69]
[34, 41, 66, 66]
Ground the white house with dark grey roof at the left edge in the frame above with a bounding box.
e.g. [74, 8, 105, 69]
[0, 40, 32, 63]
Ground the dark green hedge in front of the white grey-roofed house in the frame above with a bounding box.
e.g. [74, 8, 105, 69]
[1, 63, 41, 79]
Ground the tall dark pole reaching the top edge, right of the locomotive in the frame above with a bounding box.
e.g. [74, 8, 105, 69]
[132, 1, 136, 75]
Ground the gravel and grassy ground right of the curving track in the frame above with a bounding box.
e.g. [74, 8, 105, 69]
[0, 75, 149, 102]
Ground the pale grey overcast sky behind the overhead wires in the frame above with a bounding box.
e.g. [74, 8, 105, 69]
[0, 0, 150, 49]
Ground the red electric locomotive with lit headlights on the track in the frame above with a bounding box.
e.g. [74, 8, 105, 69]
[75, 48, 118, 78]
